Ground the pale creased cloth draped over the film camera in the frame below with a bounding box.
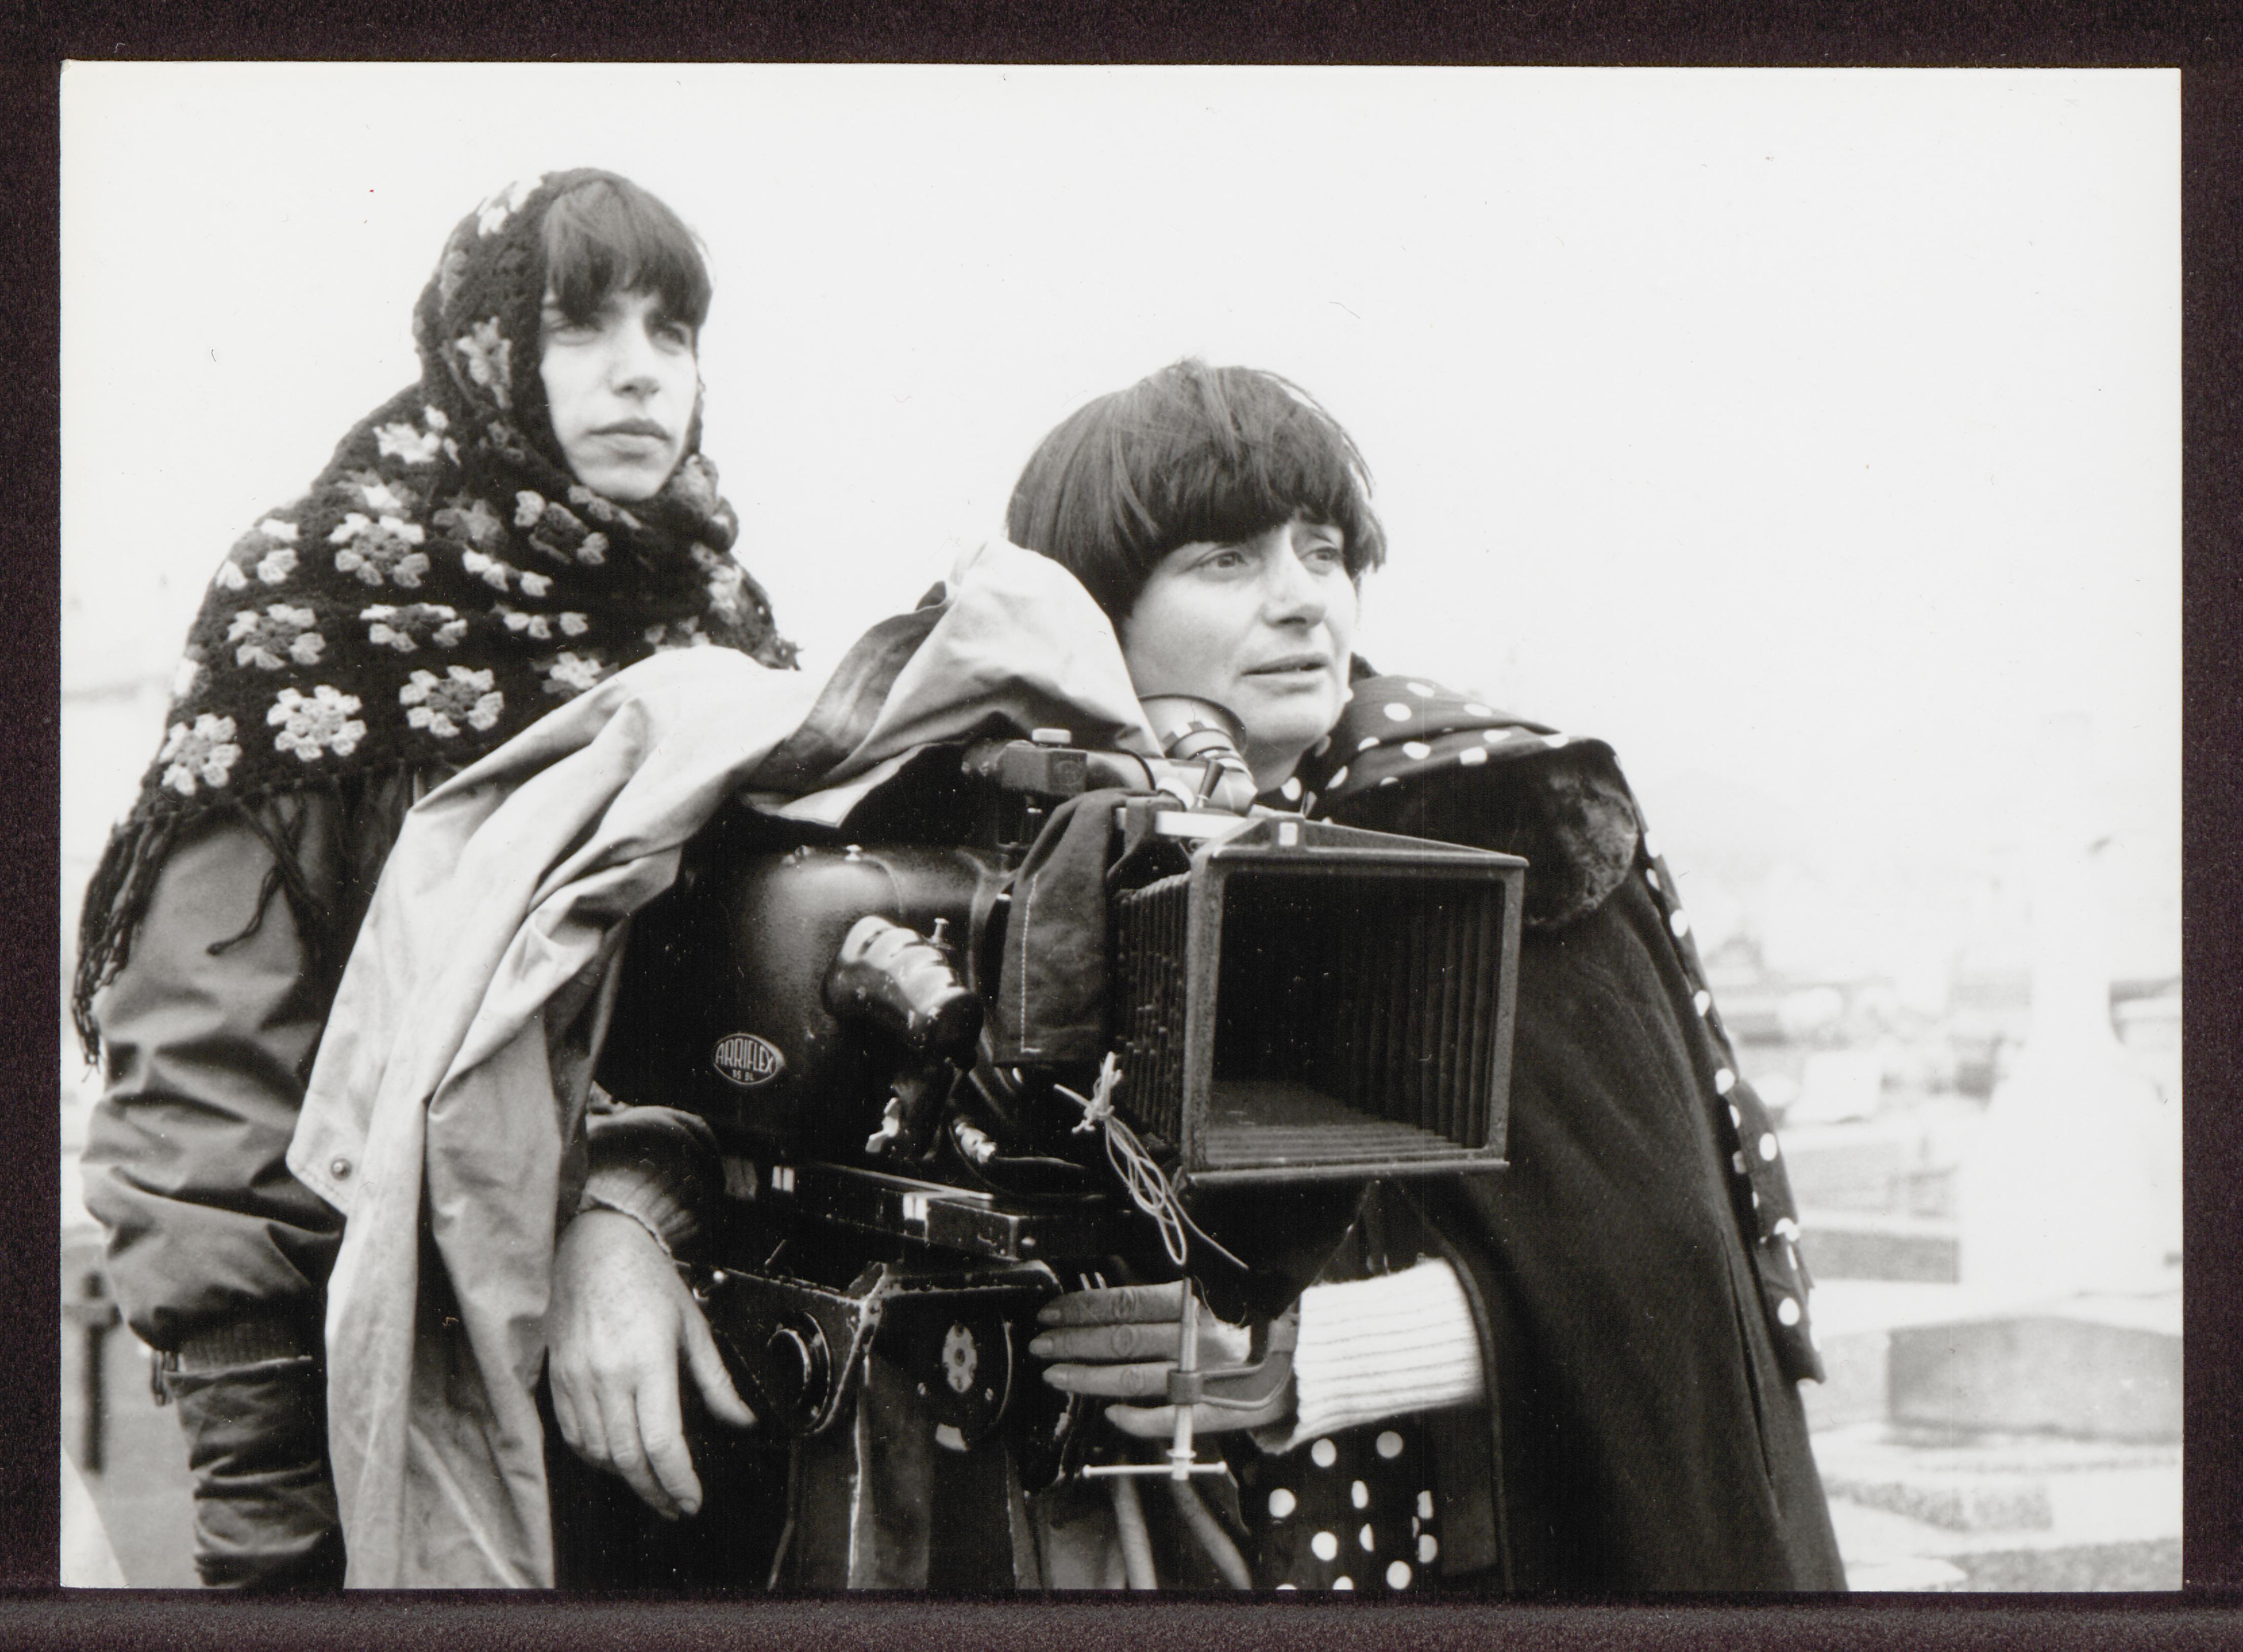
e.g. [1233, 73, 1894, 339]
[289, 545, 1157, 1587]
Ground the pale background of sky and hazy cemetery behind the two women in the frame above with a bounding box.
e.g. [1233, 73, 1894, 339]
[58, 65, 2180, 1589]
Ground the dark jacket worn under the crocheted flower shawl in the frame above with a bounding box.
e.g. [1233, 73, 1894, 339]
[85, 773, 424, 1587]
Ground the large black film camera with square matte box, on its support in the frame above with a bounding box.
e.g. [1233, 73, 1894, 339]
[601, 701, 1525, 1587]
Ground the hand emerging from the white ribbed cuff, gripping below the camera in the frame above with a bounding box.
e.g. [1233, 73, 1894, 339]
[1027, 1282, 1294, 1439]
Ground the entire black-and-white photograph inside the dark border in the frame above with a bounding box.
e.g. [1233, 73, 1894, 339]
[56, 63, 2185, 1611]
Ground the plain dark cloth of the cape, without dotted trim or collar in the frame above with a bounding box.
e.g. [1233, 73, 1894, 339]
[1436, 879, 1846, 1591]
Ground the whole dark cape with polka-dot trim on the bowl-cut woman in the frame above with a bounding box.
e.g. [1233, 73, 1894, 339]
[1335, 679, 1844, 1591]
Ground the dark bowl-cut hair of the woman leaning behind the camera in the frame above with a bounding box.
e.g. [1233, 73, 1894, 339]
[1005, 361, 1386, 625]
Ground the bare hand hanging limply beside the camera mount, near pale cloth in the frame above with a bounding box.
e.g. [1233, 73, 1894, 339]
[547, 1210, 756, 1520]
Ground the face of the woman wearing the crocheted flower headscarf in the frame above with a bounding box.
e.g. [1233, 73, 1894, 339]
[538, 291, 700, 504]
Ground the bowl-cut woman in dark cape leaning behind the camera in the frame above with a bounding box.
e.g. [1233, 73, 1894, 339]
[1027, 361, 1844, 1591]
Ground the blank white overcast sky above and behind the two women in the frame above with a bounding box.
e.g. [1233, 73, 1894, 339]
[63, 65, 2180, 966]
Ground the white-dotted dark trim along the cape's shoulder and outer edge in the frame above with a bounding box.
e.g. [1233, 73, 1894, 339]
[1263, 675, 1824, 1381]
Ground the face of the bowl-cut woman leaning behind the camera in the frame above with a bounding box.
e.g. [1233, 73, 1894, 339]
[1122, 516, 1357, 791]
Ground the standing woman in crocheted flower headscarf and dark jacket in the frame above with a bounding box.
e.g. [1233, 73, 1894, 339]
[74, 170, 794, 1587]
